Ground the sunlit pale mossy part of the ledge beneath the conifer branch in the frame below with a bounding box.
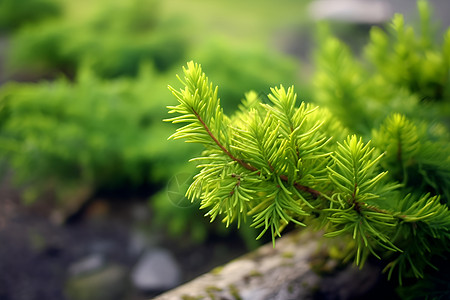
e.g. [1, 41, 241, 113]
[155, 235, 320, 300]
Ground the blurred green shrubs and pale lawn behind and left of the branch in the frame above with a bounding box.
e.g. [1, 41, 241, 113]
[0, 0, 307, 230]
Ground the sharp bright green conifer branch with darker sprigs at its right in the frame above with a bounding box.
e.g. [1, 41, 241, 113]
[166, 62, 450, 292]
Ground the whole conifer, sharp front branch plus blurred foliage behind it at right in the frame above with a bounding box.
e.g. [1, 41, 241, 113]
[163, 1, 450, 294]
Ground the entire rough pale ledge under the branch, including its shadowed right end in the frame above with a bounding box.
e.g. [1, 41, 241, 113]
[154, 232, 380, 300]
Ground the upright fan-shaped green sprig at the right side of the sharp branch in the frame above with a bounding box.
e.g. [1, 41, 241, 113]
[326, 136, 400, 264]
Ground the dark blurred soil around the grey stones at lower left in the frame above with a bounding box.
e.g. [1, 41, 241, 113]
[0, 172, 246, 300]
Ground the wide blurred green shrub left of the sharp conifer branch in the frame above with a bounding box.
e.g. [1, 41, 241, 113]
[0, 62, 193, 204]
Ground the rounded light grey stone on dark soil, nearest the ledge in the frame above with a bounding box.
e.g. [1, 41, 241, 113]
[131, 249, 181, 291]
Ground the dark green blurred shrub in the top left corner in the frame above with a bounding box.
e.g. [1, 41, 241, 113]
[0, 0, 61, 31]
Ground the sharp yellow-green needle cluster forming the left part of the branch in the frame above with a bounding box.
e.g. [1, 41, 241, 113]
[170, 63, 328, 236]
